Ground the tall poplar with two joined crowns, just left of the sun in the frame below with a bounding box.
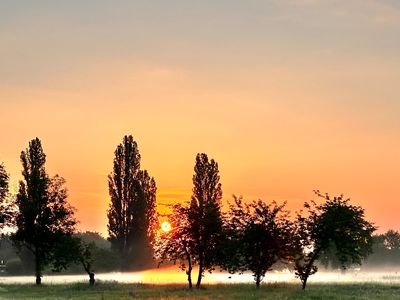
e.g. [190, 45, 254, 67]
[107, 135, 157, 269]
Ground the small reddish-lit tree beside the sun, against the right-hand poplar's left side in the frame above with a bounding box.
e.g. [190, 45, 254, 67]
[155, 204, 194, 289]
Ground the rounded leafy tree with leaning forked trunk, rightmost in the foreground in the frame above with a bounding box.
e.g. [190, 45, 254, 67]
[292, 191, 376, 289]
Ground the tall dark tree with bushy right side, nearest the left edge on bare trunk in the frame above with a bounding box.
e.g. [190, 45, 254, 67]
[12, 138, 76, 284]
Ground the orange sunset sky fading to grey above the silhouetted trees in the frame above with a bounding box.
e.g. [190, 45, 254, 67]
[0, 0, 400, 235]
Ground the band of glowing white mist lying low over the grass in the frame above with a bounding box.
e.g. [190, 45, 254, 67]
[0, 266, 400, 286]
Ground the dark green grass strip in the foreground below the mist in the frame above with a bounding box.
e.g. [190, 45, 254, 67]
[0, 283, 400, 299]
